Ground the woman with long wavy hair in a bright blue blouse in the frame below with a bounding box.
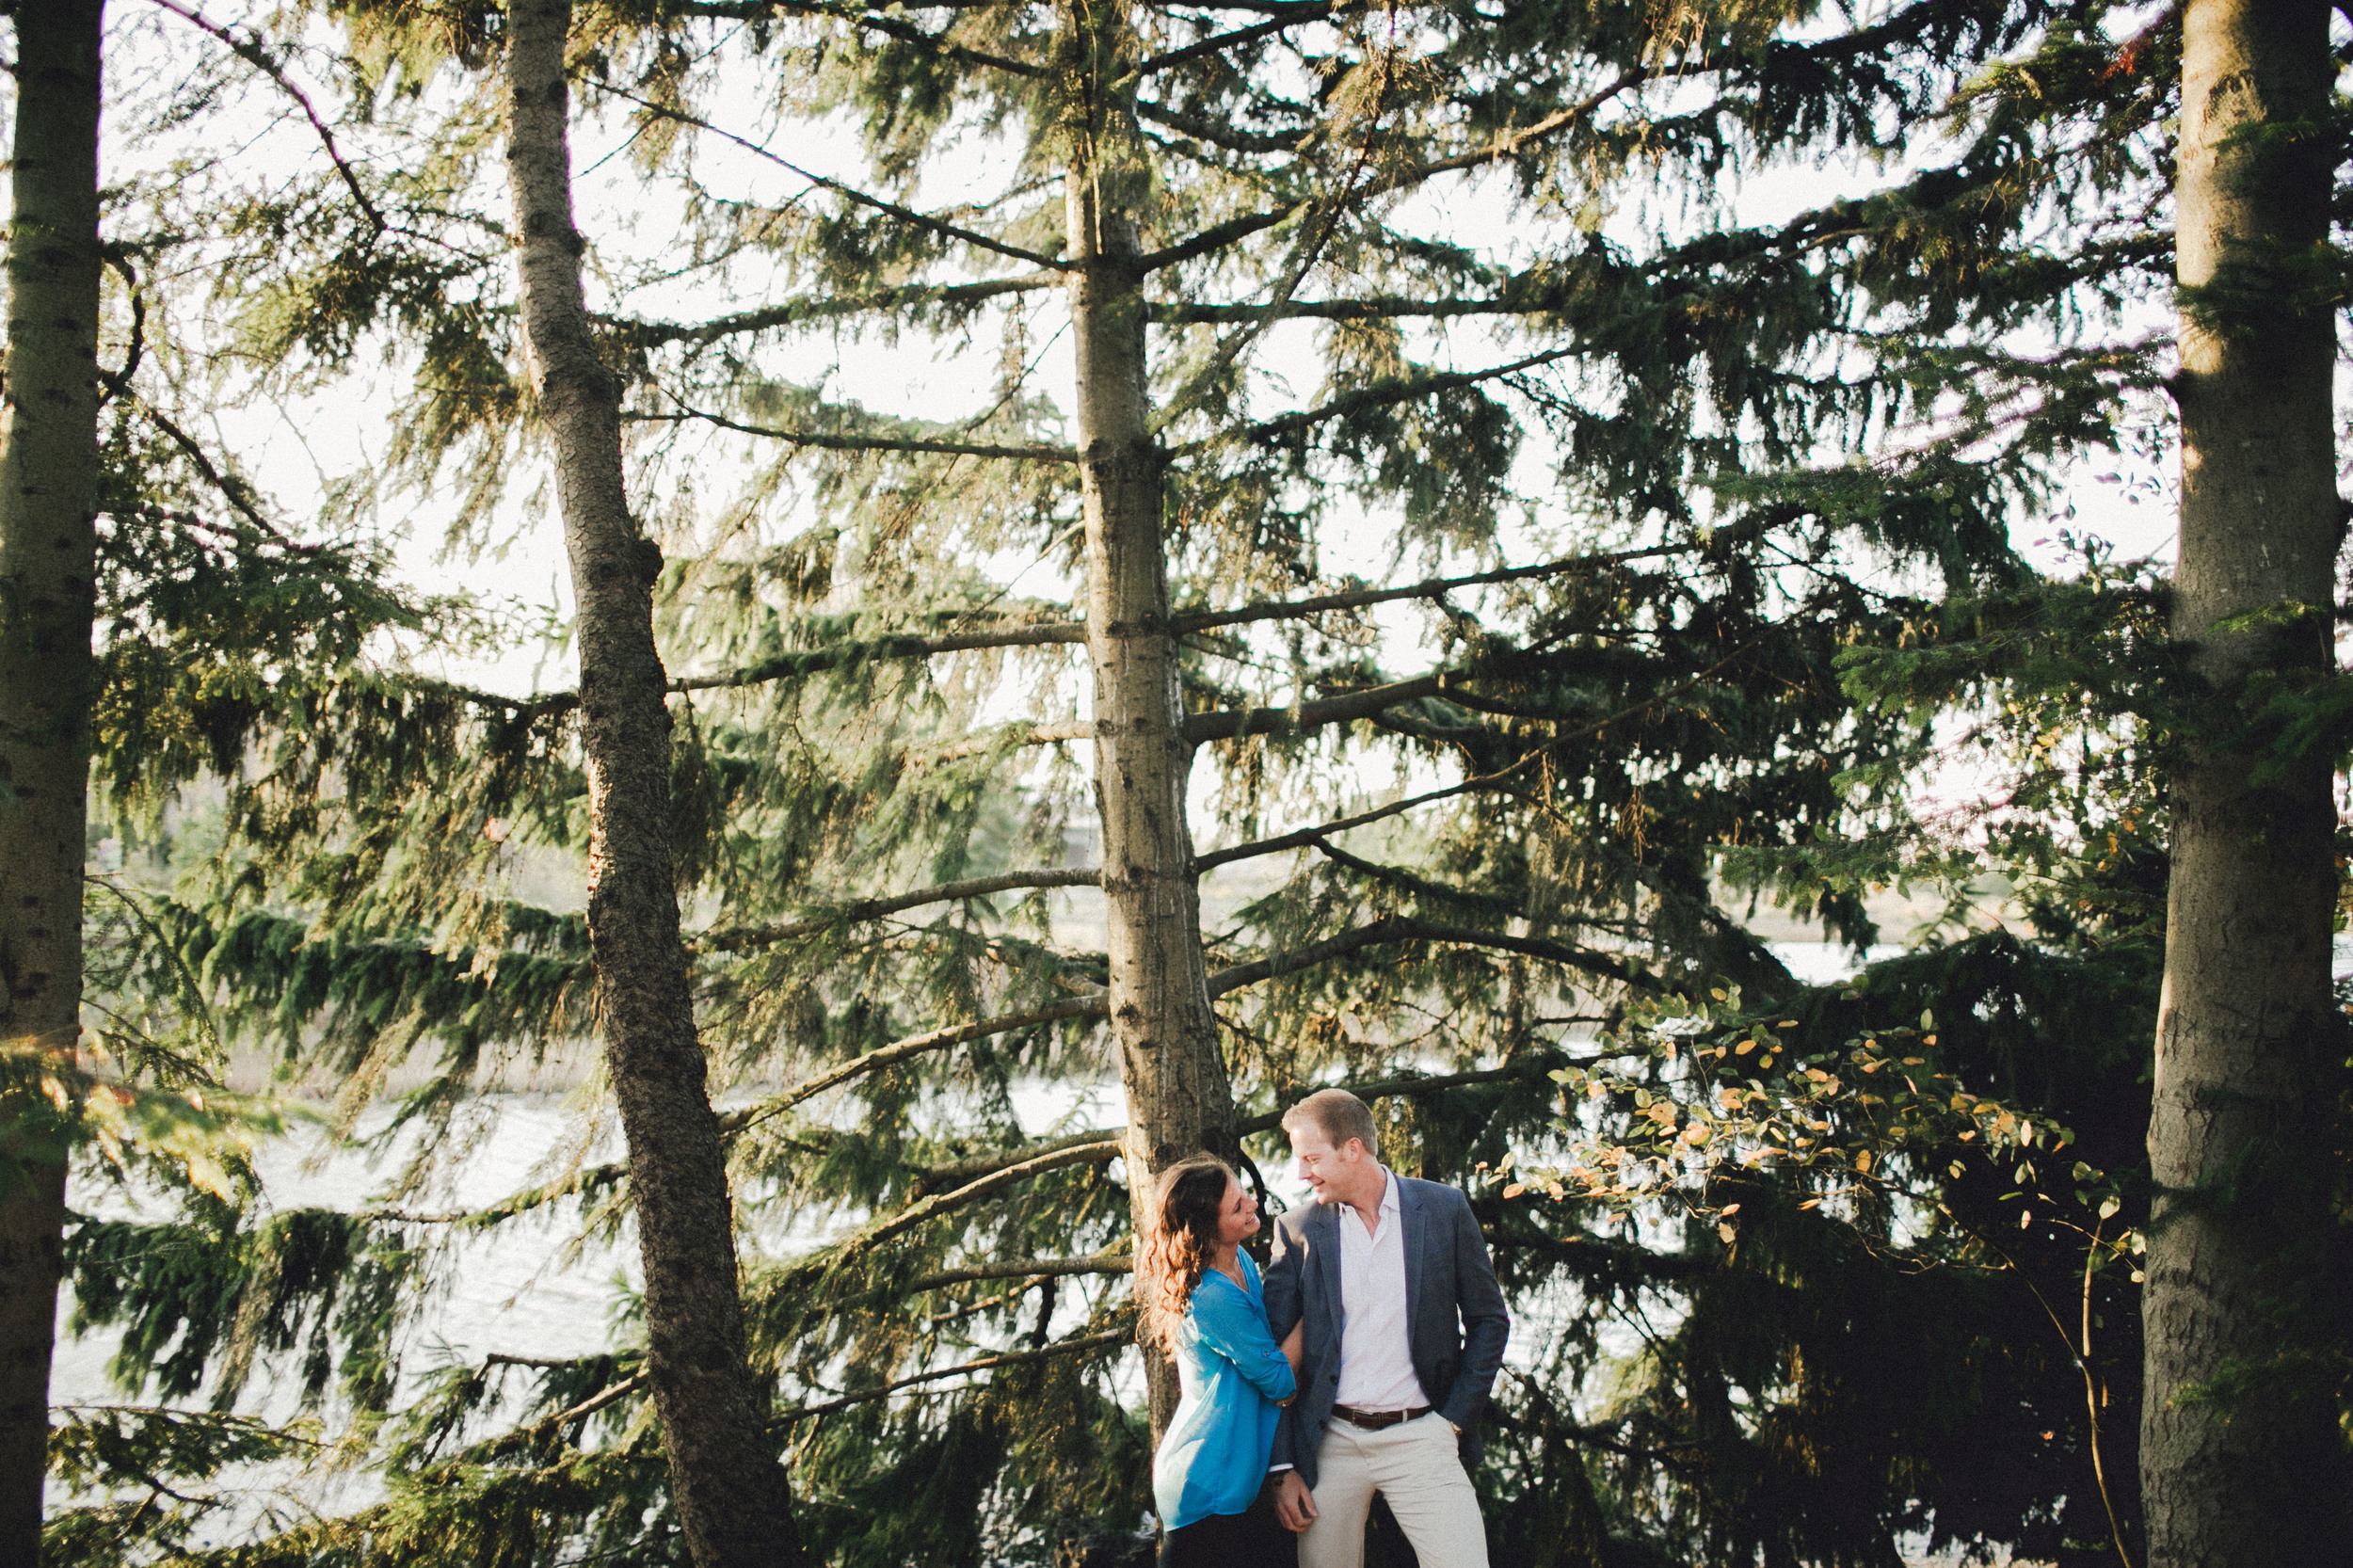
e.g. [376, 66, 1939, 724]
[1137, 1154, 1299, 1568]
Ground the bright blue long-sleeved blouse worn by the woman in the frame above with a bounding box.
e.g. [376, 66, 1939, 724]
[1153, 1253, 1299, 1530]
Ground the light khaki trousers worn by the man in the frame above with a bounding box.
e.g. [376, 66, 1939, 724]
[1299, 1415, 1487, 1568]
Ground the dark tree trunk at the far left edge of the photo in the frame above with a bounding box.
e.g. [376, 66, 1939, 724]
[0, 0, 102, 1563]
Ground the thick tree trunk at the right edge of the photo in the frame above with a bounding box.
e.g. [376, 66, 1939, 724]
[2141, 0, 2353, 1568]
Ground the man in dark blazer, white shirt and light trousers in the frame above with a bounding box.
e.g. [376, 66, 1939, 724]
[1266, 1090, 1511, 1568]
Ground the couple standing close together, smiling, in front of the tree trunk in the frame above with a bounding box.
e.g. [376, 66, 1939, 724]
[1139, 1090, 1511, 1568]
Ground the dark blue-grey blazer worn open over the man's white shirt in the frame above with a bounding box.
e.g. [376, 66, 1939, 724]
[1266, 1173, 1511, 1485]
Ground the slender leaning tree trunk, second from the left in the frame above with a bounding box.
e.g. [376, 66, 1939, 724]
[506, 0, 803, 1568]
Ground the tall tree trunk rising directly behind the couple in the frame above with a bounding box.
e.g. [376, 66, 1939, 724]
[1064, 5, 1236, 1441]
